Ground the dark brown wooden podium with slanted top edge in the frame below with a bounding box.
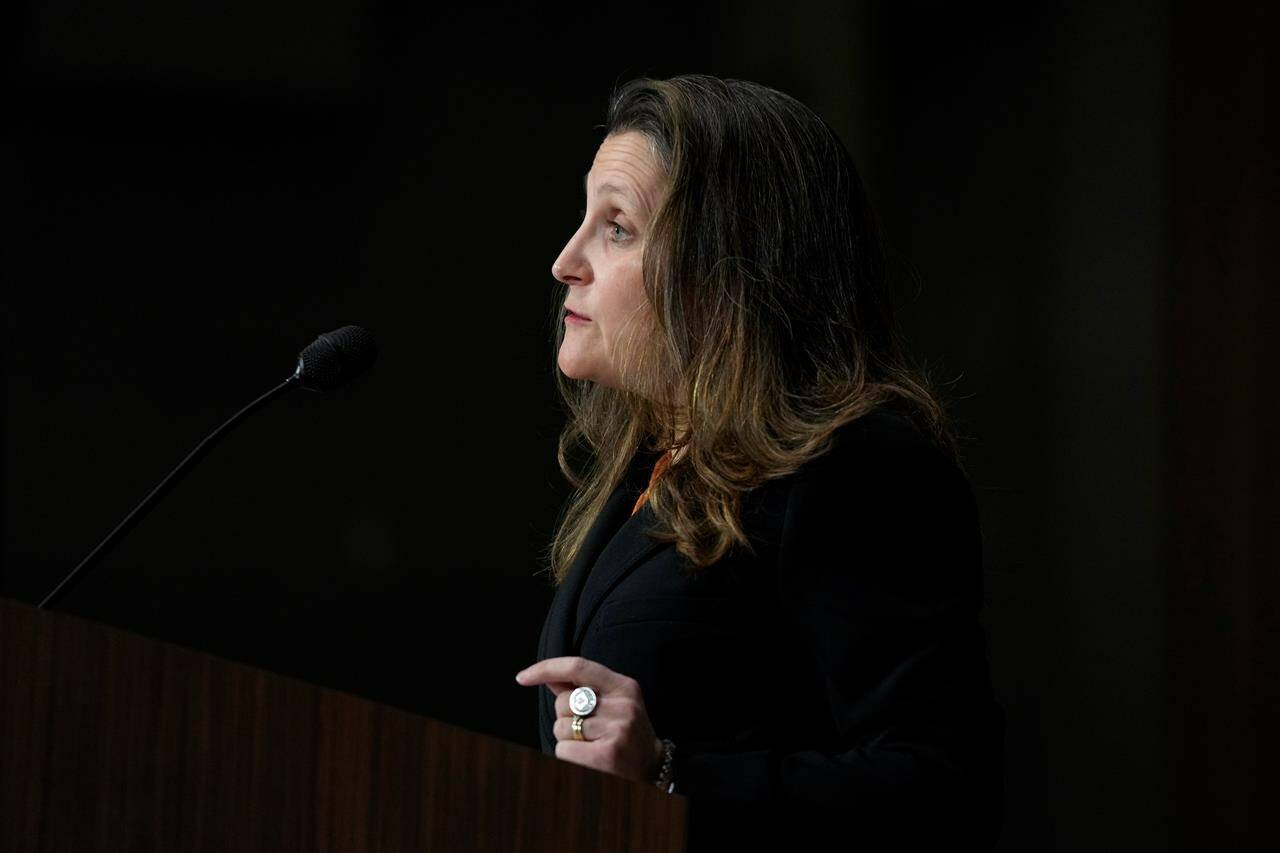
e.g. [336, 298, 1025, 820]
[0, 598, 689, 853]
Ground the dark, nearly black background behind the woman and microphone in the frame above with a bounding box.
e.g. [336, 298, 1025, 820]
[0, 0, 1280, 850]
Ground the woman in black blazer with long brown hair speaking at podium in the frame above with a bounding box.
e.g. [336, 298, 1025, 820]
[517, 76, 1005, 850]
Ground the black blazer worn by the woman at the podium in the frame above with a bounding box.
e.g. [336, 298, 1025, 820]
[538, 409, 1005, 852]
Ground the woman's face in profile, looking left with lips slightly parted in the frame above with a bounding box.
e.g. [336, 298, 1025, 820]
[552, 131, 662, 388]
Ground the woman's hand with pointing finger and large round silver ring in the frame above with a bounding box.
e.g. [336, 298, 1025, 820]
[516, 657, 663, 783]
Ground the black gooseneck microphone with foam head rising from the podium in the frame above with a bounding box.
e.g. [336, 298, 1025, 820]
[37, 325, 378, 610]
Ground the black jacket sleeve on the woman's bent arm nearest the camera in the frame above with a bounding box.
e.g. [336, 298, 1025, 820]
[675, 433, 1005, 849]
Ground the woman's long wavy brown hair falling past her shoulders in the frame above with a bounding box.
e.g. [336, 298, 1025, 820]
[545, 74, 959, 584]
